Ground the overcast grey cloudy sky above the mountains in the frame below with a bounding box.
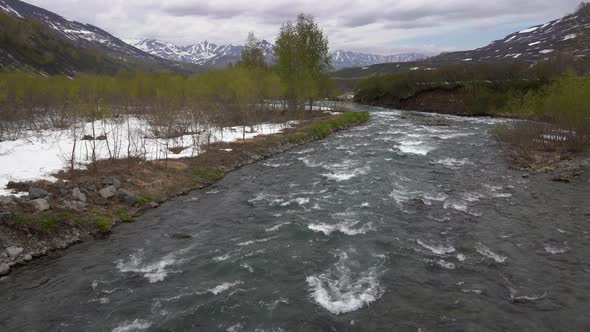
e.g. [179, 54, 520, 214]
[25, 0, 580, 54]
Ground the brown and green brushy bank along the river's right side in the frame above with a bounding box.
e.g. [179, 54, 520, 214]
[354, 57, 590, 172]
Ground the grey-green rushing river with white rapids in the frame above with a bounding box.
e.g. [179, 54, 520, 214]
[0, 107, 590, 332]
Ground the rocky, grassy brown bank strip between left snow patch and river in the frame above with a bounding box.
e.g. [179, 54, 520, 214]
[0, 112, 369, 275]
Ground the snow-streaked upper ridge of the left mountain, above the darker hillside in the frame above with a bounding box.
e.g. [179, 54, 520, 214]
[0, 0, 160, 61]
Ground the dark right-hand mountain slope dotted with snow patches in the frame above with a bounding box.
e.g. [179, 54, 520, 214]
[431, 4, 590, 63]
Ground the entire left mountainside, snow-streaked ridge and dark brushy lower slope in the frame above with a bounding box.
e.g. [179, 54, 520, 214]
[0, 0, 201, 75]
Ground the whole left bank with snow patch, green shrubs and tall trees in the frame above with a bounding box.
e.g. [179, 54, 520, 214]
[0, 14, 369, 275]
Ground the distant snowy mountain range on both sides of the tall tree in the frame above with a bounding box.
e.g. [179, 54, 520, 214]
[132, 39, 427, 69]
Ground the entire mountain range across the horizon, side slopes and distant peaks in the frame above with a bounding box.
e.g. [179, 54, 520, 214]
[0, 0, 590, 77]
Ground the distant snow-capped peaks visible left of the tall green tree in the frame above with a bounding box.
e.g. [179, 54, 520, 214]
[132, 39, 273, 67]
